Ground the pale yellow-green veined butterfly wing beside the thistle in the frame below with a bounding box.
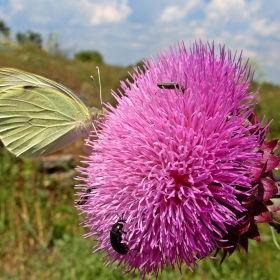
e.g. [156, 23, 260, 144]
[0, 69, 97, 157]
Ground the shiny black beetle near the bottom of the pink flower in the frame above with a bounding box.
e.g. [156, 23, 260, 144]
[110, 214, 129, 255]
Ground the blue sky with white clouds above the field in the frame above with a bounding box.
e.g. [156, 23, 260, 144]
[0, 0, 280, 84]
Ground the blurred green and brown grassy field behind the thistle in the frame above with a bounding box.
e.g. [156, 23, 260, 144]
[0, 43, 280, 280]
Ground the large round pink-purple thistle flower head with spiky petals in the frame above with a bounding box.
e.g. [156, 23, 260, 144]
[77, 42, 279, 278]
